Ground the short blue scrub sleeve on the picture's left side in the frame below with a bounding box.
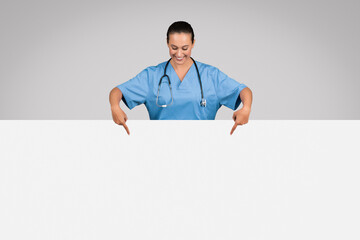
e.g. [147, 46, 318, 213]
[116, 68, 149, 110]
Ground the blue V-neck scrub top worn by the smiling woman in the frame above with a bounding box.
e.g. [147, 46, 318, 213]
[117, 60, 246, 120]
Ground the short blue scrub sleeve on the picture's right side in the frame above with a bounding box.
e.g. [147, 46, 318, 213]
[212, 67, 247, 110]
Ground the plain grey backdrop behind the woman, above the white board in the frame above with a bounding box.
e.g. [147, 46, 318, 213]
[0, 0, 360, 120]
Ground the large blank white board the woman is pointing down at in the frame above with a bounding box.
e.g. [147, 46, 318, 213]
[0, 120, 360, 240]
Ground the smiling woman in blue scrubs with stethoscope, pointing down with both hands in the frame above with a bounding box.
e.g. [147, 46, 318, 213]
[109, 21, 252, 134]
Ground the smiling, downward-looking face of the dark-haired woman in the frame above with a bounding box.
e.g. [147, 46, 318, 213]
[168, 33, 195, 65]
